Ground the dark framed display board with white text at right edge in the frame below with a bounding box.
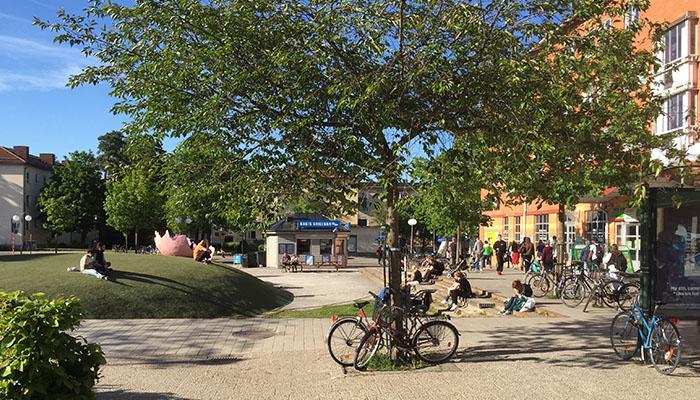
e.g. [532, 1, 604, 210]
[652, 190, 700, 317]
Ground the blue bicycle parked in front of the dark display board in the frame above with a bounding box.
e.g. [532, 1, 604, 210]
[610, 303, 681, 375]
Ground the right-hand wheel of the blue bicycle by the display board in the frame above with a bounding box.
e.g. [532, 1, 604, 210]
[648, 318, 681, 375]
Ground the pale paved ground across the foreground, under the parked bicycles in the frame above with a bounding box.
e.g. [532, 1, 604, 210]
[87, 315, 700, 400]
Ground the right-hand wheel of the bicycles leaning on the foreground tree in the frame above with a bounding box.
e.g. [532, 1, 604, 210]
[413, 321, 459, 364]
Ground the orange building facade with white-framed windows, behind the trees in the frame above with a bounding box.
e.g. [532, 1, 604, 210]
[480, 0, 700, 265]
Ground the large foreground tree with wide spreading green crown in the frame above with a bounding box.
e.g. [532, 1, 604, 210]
[38, 0, 676, 310]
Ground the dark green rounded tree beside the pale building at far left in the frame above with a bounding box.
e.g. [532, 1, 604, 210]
[37, 151, 105, 244]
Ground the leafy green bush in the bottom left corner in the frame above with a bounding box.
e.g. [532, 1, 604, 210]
[0, 292, 105, 400]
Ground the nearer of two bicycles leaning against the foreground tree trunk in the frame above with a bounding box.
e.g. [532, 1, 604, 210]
[353, 290, 459, 371]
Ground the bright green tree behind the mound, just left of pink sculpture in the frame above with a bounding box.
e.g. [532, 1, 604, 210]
[104, 134, 164, 248]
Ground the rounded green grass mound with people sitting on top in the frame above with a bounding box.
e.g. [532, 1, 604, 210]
[0, 252, 293, 318]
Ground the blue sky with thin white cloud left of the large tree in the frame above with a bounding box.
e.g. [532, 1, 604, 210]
[0, 0, 179, 159]
